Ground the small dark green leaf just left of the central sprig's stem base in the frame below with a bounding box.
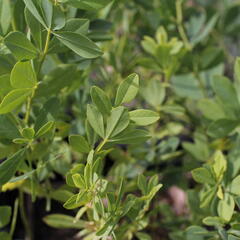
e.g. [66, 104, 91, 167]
[69, 135, 91, 153]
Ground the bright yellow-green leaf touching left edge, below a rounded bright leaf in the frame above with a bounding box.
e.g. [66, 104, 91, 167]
[0, 88, 32, 114]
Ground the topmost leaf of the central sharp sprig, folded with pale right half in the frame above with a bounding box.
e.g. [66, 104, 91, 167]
[115, 73, 139, 106]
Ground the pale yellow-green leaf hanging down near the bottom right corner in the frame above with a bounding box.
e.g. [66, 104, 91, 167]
[218, 193, 235, 222]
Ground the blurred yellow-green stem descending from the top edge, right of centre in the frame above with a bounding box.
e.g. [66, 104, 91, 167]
[176, 0, 192, 50]
